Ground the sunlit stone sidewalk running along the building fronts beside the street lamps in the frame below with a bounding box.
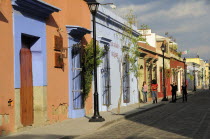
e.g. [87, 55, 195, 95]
[1, 91, 193, 139]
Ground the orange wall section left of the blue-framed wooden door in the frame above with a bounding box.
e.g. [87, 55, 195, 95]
[0, 0, 14, 135]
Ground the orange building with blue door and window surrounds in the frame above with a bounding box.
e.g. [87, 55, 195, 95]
[0, 0, 92, 134]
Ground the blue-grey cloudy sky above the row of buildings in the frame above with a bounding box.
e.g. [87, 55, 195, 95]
[98, 0, 210, 60]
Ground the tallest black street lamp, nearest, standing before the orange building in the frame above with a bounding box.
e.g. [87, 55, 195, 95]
[85, 0, 105, 122]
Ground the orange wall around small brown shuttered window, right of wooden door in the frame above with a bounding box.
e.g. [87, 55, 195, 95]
[44, 0, 92, 123]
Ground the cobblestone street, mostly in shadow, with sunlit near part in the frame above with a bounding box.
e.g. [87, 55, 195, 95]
[76, 90, 210, 139]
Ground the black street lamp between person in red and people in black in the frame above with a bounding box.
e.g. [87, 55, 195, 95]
[161, 41, 168, 101]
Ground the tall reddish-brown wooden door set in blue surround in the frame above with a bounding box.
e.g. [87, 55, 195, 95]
[20, 47, 33, 126]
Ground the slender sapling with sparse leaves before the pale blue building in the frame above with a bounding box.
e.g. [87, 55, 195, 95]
[118, 10, 147, 114]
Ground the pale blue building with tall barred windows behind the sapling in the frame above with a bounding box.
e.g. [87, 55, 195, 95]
[96, 6, 140, 111]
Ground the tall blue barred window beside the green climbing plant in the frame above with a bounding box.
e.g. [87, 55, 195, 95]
[69, 40, 85, 118]
